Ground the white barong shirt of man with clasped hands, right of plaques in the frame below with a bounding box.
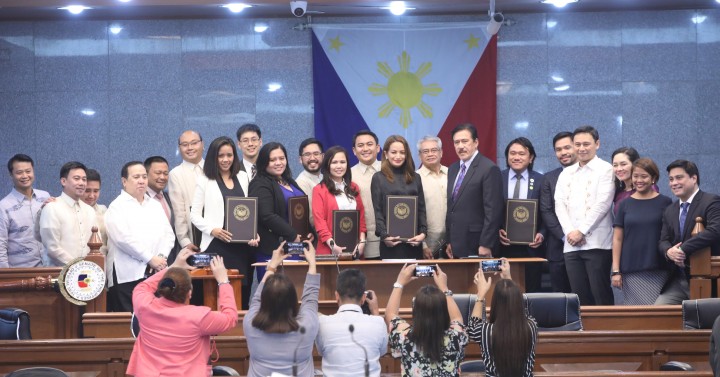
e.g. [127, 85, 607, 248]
[555, 156, 615, 253]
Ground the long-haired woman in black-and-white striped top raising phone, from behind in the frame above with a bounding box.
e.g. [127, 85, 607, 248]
[468, 258, 537, 377]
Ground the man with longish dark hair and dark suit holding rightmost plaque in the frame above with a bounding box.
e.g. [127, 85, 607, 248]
[500, 137, 545, 293]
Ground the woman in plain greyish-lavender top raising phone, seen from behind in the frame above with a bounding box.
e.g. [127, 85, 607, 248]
[243, 241, 320, 377]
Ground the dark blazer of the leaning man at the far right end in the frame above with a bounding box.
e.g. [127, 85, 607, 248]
[658, 190, 720, 258]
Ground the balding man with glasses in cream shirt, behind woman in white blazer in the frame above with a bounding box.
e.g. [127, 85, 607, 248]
[168, 130, 205, 247]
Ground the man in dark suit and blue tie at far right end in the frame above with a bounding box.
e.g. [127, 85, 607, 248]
[655, 160, 720, 305]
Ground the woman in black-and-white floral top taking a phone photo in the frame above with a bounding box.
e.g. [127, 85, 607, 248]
[385, 264, 468, 377]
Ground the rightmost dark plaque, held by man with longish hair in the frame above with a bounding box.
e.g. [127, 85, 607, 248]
[505, 199, 538, 245]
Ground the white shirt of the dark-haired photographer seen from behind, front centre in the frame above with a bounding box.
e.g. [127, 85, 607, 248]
[315, 304, 388, 377]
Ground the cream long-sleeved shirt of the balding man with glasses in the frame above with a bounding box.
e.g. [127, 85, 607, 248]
[168, 160, 205, 247]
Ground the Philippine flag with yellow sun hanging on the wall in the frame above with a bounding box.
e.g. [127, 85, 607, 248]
[312, 22, 497, 166]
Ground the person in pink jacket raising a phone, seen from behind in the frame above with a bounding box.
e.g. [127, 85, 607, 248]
[127, 249, 238, 377]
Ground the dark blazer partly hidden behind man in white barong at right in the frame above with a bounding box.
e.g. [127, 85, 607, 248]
[540, 167, 565, 262]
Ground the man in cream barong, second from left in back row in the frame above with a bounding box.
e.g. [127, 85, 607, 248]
[40, 161, 97, 266]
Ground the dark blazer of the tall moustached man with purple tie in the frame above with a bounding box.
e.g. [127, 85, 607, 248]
[445, 153, 505, 257]
